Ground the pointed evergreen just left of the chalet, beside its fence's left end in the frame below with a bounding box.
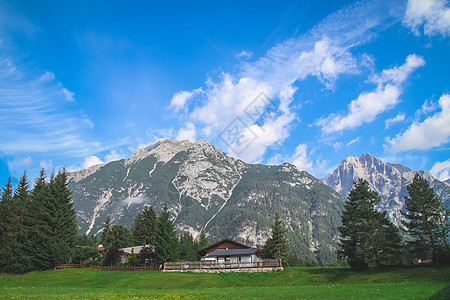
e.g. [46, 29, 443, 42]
[153, 205, 180, 264]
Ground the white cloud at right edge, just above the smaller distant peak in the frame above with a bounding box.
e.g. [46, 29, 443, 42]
[385, 94, 450, 152]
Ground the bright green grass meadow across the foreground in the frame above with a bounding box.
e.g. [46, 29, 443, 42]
[0, 267, 450, 299]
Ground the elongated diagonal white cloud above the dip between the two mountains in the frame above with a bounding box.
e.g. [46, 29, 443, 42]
[316, 54, 425, 134]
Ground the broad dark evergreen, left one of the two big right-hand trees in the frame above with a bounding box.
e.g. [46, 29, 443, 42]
[338, 179, 401, 270]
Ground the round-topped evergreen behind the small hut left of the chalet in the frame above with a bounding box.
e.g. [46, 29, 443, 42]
[131, 206, 156, 246]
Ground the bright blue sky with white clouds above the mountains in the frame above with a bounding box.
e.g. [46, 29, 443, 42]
[0, 0, 450, 185]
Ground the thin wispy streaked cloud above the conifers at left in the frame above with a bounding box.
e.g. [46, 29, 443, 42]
[0, 52, 100, 158]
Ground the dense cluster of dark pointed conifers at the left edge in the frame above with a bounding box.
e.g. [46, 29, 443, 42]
[0, 169, 78, 273]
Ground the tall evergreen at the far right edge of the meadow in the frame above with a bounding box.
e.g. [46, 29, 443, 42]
[403, 174, 449, 261]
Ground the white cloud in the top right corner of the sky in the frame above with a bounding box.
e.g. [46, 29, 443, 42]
[403, 0, 450, 37]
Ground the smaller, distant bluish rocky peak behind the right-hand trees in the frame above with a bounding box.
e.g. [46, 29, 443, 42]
[322, 153, 450, 225]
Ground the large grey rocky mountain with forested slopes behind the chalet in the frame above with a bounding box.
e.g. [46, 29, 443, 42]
[69, 140, 345, 264]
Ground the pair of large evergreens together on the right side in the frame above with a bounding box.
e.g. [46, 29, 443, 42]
[338, 174, 450, 270]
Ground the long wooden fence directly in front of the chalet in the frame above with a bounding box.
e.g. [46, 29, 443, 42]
[164, 259, 282, 271]
